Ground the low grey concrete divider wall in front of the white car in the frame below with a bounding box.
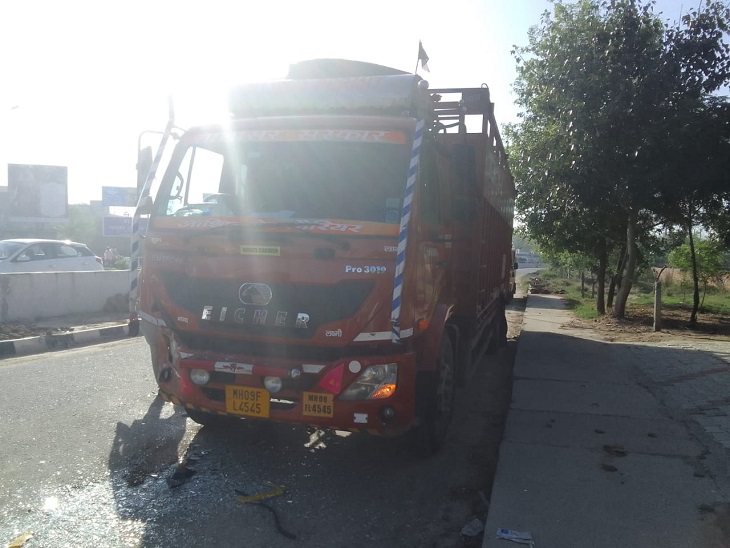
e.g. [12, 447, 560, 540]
[0, 270, 130, 323]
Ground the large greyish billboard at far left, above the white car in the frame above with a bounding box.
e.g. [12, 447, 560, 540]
[8, 164, 68, 223]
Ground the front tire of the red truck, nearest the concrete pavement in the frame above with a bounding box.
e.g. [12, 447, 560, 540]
[413, 333, 456, 456]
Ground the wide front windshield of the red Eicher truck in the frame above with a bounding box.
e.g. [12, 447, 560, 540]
[155, 130, 411, 223]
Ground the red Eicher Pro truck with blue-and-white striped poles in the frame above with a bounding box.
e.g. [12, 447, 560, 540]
[138, 60, 515, 451]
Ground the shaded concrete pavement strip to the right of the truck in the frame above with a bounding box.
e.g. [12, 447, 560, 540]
[483, 295, 730, 548]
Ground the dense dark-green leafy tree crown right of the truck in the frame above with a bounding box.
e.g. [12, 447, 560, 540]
[505, 0, 730, 315]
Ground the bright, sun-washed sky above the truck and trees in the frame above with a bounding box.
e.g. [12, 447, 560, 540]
[0, 0, 699, 204]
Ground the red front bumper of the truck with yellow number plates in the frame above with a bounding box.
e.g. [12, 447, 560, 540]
[145, 329, 416, 436]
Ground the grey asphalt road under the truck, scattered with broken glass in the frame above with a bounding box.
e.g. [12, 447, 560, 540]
[0, 332, 514, 548]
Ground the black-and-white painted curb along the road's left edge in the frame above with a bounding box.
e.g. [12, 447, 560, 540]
[0, 325, 138, 360]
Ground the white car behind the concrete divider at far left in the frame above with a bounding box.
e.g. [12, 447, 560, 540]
[0, 238, 104, 274]
